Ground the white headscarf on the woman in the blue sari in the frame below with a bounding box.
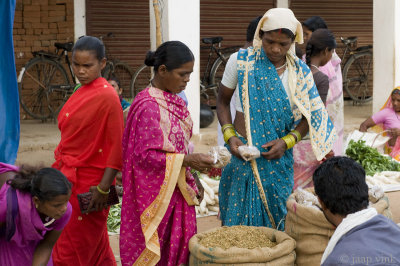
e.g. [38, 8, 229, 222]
[253, 8, 303, 52]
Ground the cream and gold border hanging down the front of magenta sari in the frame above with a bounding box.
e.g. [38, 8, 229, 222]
[134, 153, 185, 265]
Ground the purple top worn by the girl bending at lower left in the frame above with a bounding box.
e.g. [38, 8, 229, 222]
[0, 184, 72, 266]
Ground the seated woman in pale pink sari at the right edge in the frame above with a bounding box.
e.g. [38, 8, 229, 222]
[360, 86, 400, 161]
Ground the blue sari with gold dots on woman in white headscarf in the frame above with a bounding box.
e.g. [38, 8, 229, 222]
[219, 48, 335, 230]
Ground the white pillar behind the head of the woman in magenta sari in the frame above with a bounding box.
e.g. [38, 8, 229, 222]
[149, 0, 200, 134]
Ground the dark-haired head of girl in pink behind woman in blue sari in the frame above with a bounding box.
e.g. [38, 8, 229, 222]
[306, 29, 336, 66]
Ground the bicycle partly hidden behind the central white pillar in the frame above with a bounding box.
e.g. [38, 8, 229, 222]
[131, 37, 240, 105]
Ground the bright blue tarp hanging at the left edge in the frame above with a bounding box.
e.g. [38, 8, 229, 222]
[0, 0, 19, 164]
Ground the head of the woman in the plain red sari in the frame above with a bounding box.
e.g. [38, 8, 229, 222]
[72, 36, 106, 85]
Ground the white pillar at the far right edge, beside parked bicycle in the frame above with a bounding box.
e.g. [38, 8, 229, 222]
[372, 0, 400, 113]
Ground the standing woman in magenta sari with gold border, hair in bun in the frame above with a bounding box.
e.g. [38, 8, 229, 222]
[120, 41, 213, 265]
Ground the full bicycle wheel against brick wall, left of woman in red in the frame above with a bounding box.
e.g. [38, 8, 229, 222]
[18, 57, 72, 120]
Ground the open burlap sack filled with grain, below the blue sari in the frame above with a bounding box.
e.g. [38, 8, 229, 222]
[189, 226, 296, 266]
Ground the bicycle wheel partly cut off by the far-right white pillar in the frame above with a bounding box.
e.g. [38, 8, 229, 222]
[343, 51, 373, 103]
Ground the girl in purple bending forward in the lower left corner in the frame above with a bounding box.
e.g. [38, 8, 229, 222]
[0, 163, 72, 266]
